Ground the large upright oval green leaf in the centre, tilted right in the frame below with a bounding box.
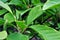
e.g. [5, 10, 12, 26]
[27, 5, 42, 25]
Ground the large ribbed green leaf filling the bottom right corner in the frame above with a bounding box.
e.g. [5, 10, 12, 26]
[30, 25, 60, 40]
